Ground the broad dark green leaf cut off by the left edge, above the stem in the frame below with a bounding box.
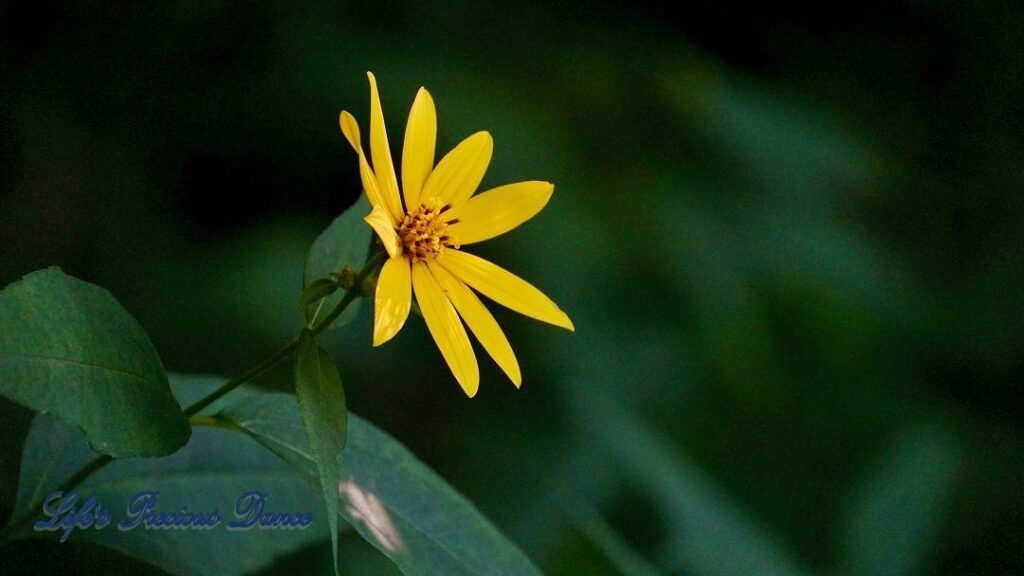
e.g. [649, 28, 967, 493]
[0, 268, 190, 458]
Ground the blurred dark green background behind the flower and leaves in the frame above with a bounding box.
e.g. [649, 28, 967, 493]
[0, 1, 1024, 575]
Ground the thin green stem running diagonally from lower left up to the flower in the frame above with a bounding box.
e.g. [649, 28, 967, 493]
[0, 251, 385, 543]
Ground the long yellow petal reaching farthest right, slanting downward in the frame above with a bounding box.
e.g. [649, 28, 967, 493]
[437, 249, 575, 330]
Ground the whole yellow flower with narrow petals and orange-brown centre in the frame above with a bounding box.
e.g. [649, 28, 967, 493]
[339, 73, 573, 398]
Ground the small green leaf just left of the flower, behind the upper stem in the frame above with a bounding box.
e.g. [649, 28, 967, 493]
[303, 194, 371, 328]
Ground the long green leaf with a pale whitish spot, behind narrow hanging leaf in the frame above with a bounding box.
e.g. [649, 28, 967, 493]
[219, 381, 540, 575]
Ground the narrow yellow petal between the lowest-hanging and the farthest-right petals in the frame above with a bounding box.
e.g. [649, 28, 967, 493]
[427, 262, 522, 387]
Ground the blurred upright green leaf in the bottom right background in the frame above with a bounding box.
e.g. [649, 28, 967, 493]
[843, 427, 959, 576]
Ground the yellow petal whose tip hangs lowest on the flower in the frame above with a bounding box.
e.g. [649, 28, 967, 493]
[413, 262, 480, 398]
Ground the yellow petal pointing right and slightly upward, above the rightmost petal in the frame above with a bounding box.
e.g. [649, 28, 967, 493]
[446, 181, 555, 245]
